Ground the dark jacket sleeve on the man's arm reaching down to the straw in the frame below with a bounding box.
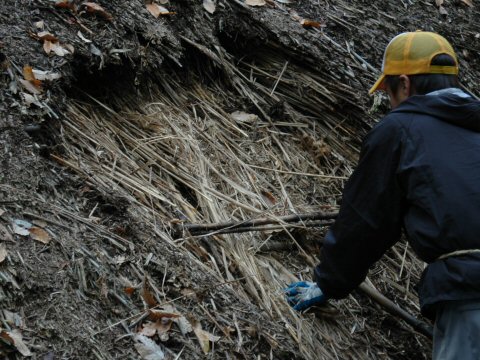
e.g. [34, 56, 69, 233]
[314, 117, 403, 299]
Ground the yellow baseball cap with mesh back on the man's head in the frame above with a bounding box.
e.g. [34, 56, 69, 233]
[368, 31, 458, 94]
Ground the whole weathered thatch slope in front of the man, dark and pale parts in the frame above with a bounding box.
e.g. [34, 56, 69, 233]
[0, 0, 480, 359]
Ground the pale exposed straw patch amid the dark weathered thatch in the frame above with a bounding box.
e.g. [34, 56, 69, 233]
[54, 46, 428, 359]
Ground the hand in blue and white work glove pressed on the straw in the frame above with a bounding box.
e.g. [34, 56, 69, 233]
[285, 281, 327, 311]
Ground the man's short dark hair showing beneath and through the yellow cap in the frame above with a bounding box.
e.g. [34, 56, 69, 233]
[385, 54, 460, 95]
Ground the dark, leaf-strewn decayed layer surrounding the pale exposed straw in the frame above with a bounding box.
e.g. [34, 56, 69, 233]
[0, 0, 480, 359]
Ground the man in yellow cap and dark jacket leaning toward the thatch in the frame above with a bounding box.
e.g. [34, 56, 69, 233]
[286, 32, 480, 360]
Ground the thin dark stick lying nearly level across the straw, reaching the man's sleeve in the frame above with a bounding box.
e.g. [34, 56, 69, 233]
[179, 211, 338, 235]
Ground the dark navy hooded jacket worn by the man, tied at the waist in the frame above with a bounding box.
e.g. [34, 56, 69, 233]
[315, 92, 480, 317]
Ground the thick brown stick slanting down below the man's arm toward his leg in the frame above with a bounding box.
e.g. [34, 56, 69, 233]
[358, 282, 433, 339]
